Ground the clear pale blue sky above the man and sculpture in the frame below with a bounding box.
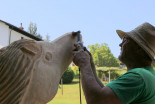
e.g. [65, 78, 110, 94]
[0, 0, 155, 58]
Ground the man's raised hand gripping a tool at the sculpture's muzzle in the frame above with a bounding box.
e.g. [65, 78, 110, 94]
[73, 44, 90, 67]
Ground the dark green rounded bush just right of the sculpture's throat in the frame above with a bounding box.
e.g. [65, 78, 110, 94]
[62, 67, 74, 84]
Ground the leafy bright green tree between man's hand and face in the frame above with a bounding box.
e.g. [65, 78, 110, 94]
[88, 43, 119, 67]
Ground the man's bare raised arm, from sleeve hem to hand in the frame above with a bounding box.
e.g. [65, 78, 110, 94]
[73, 46, 121, 104]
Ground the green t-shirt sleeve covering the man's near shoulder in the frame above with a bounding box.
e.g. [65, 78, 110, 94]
[107, 73, 145, 104]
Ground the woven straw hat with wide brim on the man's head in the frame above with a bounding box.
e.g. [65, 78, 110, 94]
[116, 23, 155, 61]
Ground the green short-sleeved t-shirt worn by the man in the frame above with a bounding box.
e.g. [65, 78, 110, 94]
[107, 66, 155, 104]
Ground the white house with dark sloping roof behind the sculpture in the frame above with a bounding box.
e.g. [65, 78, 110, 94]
[0, 20, 42, 48]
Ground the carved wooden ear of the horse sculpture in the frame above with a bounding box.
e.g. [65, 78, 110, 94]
[21, 43, 40, 56]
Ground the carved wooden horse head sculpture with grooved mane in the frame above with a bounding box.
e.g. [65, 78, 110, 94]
[0, 33, 77, 104]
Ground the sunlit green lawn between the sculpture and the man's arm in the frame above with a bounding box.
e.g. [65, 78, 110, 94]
[47, 75, 108, 104]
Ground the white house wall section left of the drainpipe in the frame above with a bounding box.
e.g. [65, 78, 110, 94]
[0, 22, 10, 46]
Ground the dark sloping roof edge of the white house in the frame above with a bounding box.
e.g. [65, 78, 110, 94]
[0, 20, 42, 41]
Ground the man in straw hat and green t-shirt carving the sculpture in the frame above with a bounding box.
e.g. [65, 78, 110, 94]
[73, 23, 155, 104]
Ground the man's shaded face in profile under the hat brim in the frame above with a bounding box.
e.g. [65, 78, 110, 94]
[119, 36, 139, 64]
